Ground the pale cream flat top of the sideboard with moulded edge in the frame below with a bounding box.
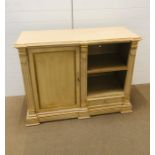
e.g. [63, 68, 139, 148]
[15, 27, 141, 48]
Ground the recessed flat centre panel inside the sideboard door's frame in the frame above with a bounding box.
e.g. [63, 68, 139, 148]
[34, 51, 76, 108]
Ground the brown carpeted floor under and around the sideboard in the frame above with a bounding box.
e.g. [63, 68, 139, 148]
[6, 84, 150, 155]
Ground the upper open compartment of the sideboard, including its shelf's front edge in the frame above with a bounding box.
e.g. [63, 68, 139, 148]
[87, 43, 130, 74]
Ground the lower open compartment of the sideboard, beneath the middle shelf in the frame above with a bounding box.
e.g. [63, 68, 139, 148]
[87, 71, 126, 98]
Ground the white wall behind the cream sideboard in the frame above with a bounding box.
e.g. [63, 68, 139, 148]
[6, 0, 150, 96]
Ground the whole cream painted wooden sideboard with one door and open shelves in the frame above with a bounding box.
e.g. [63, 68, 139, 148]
[15, 27, 141, 126]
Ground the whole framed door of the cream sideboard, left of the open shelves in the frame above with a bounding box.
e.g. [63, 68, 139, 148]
[28, 47, 80, 111]
